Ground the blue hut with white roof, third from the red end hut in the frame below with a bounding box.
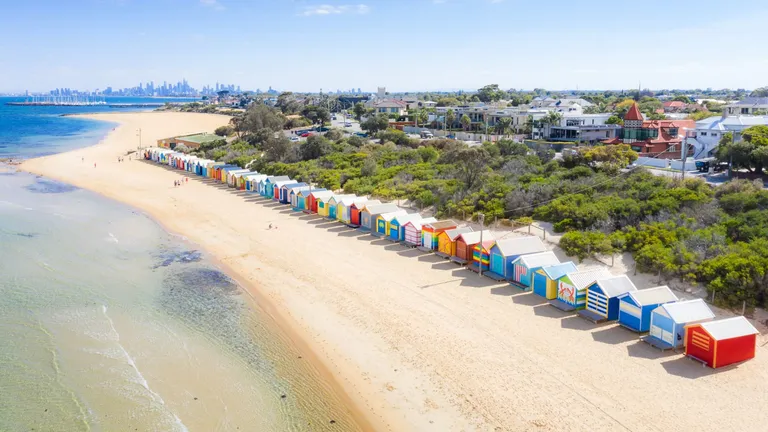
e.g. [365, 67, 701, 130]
[619, 285, 677, 333]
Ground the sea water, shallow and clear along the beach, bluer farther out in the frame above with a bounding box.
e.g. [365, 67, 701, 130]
[0, 105, 358, 431]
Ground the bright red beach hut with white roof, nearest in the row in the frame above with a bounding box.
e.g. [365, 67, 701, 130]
[685, 316, 759, 369]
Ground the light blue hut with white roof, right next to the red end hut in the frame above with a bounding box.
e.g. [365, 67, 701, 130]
[644, 299, 715, 349]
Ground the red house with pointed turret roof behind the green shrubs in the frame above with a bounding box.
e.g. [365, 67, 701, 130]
[603, 104, 696, 159]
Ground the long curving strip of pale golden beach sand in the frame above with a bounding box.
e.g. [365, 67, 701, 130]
[22, 113, 768, 431]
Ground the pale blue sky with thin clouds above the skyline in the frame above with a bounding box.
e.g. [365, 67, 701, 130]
[0, 0, 768, 92]
